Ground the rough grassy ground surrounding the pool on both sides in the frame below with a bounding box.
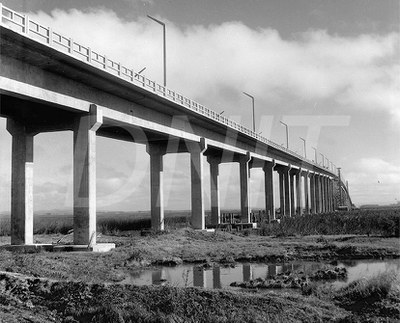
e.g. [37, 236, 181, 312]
[0, 229, 400, 322]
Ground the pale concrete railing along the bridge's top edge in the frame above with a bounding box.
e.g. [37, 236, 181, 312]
[0, 3, 333, 177]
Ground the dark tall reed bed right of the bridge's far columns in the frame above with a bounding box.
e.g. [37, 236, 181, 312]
[260, 209, 400, 237]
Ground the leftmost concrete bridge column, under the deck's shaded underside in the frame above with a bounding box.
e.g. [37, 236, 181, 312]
[7, 119, 34, 245]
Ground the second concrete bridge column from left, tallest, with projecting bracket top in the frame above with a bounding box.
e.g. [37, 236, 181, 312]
[73, 105, 103, 245]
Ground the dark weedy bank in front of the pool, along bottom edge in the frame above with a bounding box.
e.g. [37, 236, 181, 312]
[0, 273, 349, 323]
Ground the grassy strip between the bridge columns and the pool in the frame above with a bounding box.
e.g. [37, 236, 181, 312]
[0, 229, 400, 283]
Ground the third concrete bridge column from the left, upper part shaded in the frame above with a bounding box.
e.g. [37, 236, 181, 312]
[147, 143, 165, 231]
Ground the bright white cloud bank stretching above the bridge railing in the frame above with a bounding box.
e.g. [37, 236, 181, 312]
[26, 9, 400, 121]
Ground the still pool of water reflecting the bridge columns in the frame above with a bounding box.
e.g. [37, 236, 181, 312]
[121, 259, 400, 288]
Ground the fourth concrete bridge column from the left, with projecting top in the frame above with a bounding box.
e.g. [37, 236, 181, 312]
[188, 140, 206, 230]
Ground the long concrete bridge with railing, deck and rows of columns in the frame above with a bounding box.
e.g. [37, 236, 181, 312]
[0, 4, 354, 251]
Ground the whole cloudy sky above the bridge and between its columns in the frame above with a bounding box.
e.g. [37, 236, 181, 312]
[0, 0, 400, 212]
